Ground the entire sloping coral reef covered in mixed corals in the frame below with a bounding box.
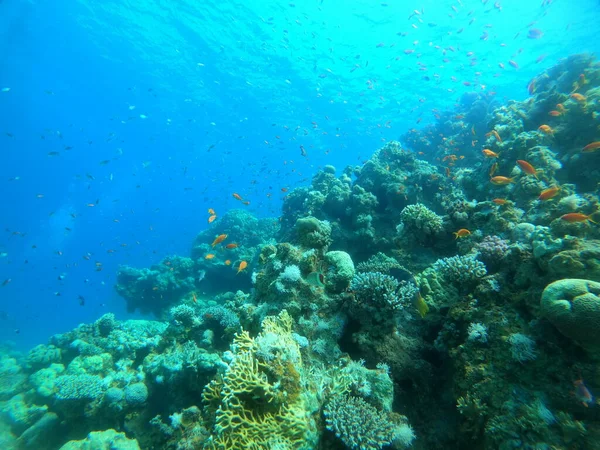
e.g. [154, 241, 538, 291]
[0, 55, 600, 450]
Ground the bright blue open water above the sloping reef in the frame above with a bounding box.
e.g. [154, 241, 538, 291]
[0, 0, 600, 349]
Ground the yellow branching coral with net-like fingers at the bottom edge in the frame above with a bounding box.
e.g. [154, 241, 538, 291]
[202, 311, 309, 450]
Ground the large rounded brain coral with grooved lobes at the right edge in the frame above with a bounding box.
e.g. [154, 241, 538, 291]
[541, 278, 600, 351]
